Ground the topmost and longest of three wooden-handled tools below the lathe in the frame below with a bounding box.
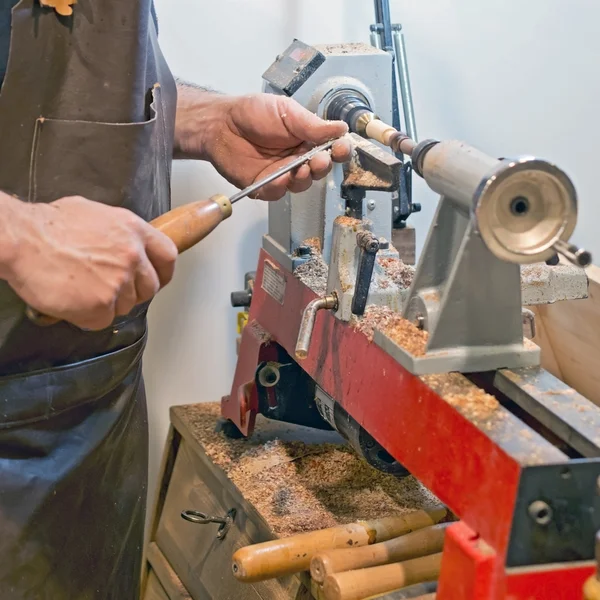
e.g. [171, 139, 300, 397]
[232, 508, 447, 582]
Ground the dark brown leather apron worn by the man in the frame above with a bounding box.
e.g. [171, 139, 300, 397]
[0, 0, 176, 600]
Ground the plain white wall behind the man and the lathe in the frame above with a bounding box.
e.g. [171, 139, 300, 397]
[145, 0, 600, 491]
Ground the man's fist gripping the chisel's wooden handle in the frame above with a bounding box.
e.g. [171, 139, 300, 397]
[0, 194, 177, 330]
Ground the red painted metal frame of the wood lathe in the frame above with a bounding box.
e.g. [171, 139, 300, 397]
[222, 250, 592, 600]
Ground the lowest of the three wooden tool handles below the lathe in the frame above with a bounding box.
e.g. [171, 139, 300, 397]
[323, 552, 442, 600]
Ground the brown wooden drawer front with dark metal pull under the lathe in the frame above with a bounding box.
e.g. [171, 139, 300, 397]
[155, 439, 310, 600]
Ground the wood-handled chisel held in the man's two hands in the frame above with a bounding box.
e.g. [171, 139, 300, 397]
[25, 140, 336, 327]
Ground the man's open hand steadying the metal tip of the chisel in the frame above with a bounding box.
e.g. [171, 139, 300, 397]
[175, 85, 352, 200]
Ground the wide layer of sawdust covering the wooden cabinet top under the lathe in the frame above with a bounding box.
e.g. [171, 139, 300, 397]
[174, 403, 440, 536]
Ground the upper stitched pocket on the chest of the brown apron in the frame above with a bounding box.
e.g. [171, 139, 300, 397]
[29, 85, 168, 220]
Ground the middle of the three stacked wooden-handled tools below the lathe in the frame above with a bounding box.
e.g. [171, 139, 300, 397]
[310, 523, 450, 583]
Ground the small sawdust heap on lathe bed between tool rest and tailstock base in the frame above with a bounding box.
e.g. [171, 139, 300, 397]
[352, 305, 427, 356]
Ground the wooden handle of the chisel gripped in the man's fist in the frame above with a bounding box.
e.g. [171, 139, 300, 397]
[25, 194, 232, 327]
